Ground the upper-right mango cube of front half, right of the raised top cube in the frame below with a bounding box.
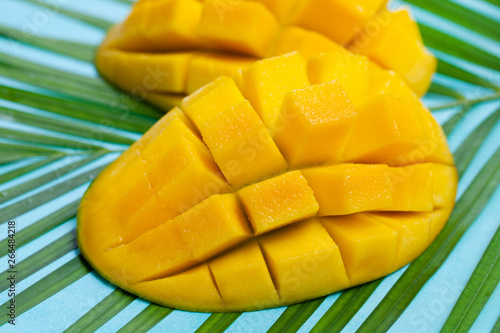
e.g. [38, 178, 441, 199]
[344, 94, 426, 164]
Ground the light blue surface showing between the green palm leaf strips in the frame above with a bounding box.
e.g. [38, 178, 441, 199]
[0, 0, 500, 332]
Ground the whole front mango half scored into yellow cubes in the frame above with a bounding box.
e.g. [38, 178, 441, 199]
[78, 53, 457, 312]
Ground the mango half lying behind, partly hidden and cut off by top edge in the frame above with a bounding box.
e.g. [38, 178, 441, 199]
[96, 0, 436, 111]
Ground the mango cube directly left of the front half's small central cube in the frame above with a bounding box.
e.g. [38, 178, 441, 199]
[173, 194, 251, 261]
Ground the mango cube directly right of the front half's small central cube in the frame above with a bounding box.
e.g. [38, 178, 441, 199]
[302, 164, 393, 216]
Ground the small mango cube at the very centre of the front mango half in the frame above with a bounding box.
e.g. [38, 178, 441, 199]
[238, 171, 318, 234]
